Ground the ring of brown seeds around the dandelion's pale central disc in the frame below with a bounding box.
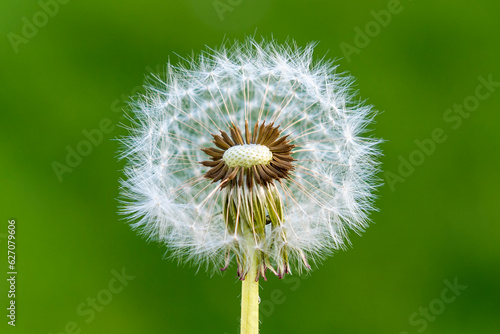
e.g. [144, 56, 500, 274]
[201, 121, 295, 189]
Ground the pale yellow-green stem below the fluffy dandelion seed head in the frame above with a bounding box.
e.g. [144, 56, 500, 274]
[241, 259, 259, 334]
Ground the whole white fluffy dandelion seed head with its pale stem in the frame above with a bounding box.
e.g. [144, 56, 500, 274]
[122, 38, 380, 333]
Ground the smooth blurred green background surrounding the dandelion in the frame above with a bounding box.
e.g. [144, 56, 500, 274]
[0, 0, 500, 334]
